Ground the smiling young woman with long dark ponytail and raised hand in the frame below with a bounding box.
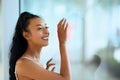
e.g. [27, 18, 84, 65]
[9, 12, 70, 80]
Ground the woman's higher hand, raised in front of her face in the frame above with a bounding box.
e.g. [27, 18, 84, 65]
[57, 18, 68, 44]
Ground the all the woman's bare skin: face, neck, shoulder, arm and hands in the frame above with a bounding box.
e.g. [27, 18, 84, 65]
[16, 18, 70, 80]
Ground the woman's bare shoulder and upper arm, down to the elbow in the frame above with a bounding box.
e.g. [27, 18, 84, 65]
[16, 59, 64, 80]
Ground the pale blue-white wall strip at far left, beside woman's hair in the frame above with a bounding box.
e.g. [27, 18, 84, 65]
[2, 0, 19, 80]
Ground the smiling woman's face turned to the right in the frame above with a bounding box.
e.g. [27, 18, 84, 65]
[25, 18, 49, 47]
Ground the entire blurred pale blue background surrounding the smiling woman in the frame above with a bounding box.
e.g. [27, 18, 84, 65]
[0, 0, 120, 80]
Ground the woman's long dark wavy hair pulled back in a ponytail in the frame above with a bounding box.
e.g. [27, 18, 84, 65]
[9, 12, 40, 80]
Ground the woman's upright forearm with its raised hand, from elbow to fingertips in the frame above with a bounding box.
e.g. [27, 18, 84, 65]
[58, 19, 70, 80]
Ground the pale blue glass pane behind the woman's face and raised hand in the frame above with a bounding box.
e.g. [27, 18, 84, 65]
[21, 0, 83, 80]
